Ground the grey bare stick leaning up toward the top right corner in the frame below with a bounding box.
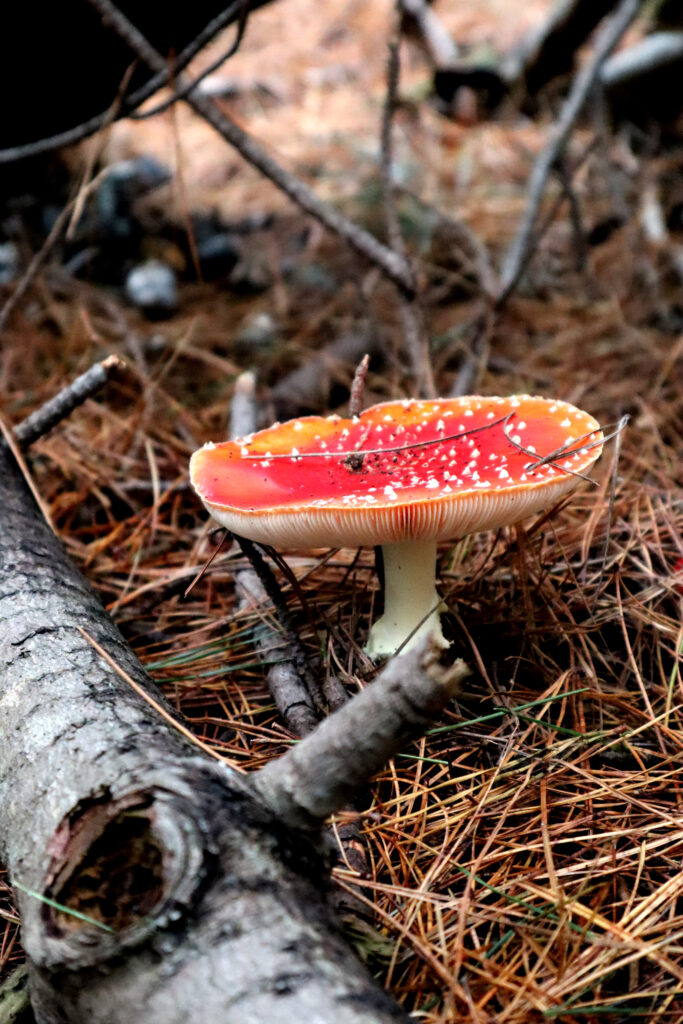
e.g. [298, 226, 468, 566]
[496, 0, 641, 306]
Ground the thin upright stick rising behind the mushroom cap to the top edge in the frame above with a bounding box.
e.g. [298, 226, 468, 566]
[380, 0, 436, 398]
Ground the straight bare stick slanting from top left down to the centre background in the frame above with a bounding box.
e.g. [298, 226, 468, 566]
[89, 0, 415, 296]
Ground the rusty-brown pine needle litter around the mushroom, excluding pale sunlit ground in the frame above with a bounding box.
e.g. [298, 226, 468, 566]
[0, 5, 683, 1024]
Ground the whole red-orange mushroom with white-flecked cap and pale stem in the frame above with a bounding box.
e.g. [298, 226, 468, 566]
[190, 395, 603, 657]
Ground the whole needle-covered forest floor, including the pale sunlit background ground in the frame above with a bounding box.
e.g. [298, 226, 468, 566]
[0, 0, 683, 1024]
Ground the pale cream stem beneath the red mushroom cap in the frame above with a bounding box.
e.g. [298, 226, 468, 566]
[366, 541, 449, 657]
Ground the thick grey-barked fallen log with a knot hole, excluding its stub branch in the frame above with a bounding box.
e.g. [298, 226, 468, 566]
[0, 446, 405, 1024]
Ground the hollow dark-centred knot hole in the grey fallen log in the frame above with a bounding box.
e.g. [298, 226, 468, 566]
[32, 790, 207, 964]
